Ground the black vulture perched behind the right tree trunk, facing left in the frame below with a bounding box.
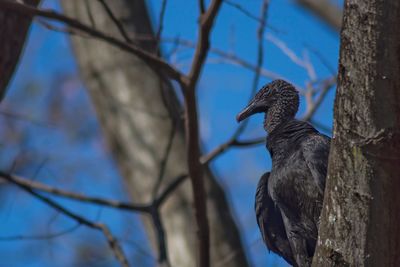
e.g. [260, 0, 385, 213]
[236, 80, 331, 267]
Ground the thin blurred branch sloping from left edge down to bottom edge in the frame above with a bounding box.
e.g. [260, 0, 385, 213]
[0, 172, 129, 267]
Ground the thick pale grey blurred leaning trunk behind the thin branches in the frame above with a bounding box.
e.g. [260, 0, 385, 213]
[62, 0, 248, 267]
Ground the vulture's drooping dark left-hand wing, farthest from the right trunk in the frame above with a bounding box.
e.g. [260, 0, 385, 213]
[255, 172, 295, 265]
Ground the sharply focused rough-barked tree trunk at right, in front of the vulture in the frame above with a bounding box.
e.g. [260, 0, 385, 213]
[313, 0, 400, 266]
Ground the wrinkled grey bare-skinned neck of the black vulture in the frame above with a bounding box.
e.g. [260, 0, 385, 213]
[264, 103, 294, 134]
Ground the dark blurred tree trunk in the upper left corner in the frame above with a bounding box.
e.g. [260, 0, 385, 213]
[0, 0, 40, 101]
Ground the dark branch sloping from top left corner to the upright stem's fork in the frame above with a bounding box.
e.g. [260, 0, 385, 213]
[0, 0, 185, 83]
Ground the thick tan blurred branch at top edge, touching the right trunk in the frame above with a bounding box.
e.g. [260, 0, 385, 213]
[296, 0, 343, 31]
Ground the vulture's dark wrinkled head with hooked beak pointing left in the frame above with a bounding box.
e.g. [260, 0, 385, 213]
[236, 80, 299, 122]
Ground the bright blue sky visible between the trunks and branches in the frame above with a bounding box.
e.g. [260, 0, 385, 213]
[0, 0, 339, 266]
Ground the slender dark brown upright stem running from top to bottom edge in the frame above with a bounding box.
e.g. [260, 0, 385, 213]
[182, 0, 222, 267]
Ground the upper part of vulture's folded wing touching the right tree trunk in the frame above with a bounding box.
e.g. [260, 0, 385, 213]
[303, 134, 330, 195]
